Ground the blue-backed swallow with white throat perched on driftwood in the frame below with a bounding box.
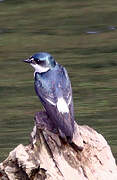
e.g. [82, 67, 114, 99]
[24, 52, 74, 142]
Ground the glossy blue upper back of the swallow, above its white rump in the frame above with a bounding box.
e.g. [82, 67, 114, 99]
[35, 65, 72, 106]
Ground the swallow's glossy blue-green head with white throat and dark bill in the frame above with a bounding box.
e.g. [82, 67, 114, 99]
[24, 52, 56, 73]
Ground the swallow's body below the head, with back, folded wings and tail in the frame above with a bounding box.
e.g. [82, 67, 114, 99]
[35, 65, 74, 140]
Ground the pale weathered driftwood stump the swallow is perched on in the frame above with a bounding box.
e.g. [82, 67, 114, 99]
[0, 112, 117, 180]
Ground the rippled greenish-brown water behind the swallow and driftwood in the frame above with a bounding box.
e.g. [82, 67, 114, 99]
[0, 0, 117, 161]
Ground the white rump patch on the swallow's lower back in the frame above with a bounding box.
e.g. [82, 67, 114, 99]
[57, 97, 69, 113]
